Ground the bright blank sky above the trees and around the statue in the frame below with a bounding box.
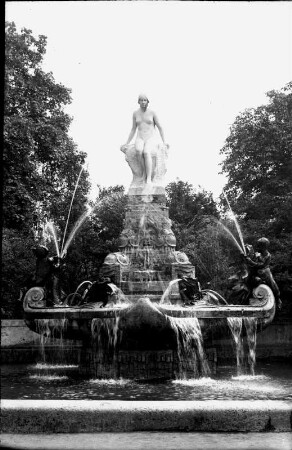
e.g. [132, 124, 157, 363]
[6, 1, 292, 198]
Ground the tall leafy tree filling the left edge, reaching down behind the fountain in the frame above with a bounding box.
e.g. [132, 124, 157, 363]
[2, 22, 89, 317]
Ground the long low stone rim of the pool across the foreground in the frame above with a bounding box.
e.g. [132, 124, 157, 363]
[1, 400, 292, 434]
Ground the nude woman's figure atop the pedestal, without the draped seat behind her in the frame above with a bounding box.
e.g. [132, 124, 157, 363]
[121, 94, 169, 185]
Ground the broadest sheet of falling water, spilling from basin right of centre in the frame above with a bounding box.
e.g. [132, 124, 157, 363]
[168, 317, 210, 378]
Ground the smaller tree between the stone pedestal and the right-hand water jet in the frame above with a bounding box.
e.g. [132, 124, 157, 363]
[166, 181, 233, 293]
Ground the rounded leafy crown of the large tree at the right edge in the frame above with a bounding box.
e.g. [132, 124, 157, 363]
[221, 82, 292, 235]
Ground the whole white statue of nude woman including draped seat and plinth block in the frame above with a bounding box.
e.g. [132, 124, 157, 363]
[121, 94, 169, 195]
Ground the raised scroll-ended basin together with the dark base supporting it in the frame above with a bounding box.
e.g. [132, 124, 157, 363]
[25, 286, 275, 380]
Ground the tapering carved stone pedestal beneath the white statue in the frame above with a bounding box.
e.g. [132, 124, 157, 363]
[100, 192, 195, 300]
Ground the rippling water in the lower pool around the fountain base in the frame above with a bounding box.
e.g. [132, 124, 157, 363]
[1, 362, 292, 401]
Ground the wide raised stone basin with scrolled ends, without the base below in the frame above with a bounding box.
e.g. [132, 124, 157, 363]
[24, 285, 275, 347]
